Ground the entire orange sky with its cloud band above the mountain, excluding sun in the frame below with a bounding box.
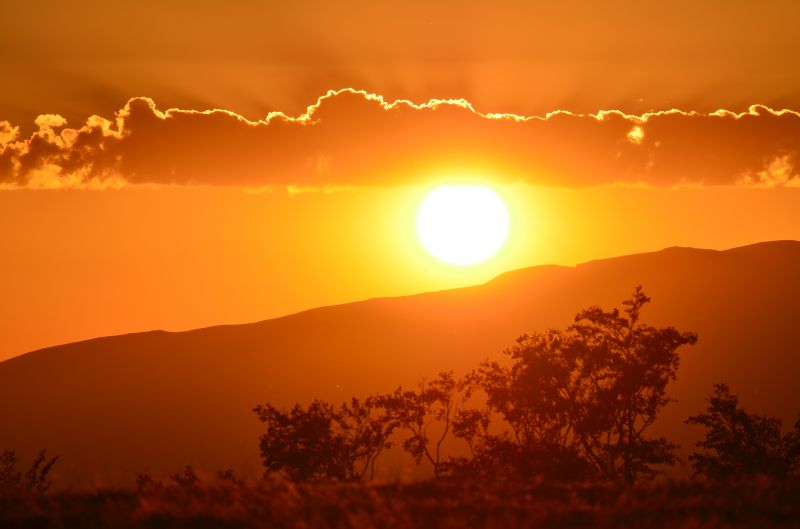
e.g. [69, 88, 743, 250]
[0, 0, 800, 360]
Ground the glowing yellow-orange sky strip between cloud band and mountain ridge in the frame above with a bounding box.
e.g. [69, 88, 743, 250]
[0, 180, 800, 358]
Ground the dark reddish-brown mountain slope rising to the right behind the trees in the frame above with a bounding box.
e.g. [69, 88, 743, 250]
[0, 241, 800, 485]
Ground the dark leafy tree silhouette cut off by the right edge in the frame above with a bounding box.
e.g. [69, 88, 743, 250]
[685, 384, 800, 480]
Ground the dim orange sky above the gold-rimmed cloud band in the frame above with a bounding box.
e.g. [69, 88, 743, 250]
[0, 0, 800, 126]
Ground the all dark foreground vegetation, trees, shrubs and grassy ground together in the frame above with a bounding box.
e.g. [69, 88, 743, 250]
[0, 288, 800, 529]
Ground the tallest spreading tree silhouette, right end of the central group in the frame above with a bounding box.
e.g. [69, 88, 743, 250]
[473, 287, 697, 483]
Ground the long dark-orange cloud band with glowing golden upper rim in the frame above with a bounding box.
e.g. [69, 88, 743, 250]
[0, 89, 800, 189]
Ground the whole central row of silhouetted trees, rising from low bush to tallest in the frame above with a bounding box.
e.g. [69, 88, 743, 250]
[254, 287, 692, 483]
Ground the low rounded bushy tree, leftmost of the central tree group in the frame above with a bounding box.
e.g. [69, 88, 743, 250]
[254, 397, 394, 481]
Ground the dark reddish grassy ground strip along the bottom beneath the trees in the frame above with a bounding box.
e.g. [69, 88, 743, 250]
[0, 480, 800, 529]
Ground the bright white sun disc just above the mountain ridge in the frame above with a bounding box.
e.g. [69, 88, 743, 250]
[417, 185, 509, 266]
